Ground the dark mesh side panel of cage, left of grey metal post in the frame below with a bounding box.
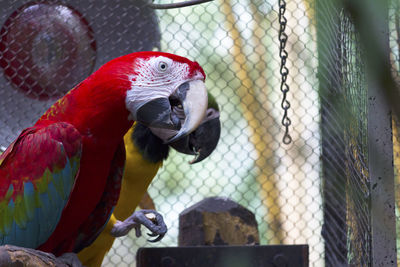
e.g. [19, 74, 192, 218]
[316, 1, 371, 266]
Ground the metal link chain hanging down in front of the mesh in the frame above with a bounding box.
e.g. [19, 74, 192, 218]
[279, 0, 292, 145]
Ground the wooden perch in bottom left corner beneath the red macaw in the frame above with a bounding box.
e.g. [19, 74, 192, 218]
[0, 245, 69, 267]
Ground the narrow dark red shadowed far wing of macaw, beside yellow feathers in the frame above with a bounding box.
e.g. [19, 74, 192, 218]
[74, 141, 125, 253]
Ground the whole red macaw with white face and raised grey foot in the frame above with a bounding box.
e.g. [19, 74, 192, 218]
[0, 52, 207, 261]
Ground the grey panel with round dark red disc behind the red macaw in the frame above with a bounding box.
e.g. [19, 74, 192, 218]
[0, 1, 160, 148]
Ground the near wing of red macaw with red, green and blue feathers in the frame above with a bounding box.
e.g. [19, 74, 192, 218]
[0, 122, 82, 248]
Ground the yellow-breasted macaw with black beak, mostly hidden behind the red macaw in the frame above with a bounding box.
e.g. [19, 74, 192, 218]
[78, 94, 221, 267]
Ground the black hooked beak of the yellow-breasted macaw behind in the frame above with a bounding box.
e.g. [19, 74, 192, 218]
[170, 108, 221, 164]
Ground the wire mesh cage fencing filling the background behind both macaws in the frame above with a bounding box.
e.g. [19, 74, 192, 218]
[0, 0, 400, 266]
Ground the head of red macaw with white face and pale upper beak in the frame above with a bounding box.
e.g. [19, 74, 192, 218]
[125, 52, 208, 142]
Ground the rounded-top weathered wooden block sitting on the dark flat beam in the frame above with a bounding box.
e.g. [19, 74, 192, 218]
[178, 197, 260, 246]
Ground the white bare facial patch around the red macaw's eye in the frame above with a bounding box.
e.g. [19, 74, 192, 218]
[125, 56, 189, 120]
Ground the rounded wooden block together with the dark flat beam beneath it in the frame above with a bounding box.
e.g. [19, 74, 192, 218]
[136, 197, 309, 267]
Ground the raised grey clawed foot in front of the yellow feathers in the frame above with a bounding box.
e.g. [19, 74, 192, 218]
[111, 210, 167, 242]
